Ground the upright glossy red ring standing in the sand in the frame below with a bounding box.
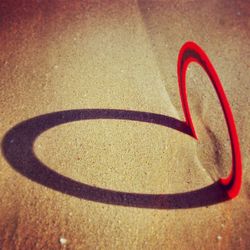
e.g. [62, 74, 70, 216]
[177, 42, 242, 199]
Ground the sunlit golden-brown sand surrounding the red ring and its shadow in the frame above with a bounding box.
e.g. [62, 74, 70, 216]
[0, 0, 250, 250]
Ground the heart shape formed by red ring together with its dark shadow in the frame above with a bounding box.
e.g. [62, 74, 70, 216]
[1, 42, 242, 206]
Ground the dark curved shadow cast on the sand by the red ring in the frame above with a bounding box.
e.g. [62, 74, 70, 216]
[2, 109, 228, 209]
